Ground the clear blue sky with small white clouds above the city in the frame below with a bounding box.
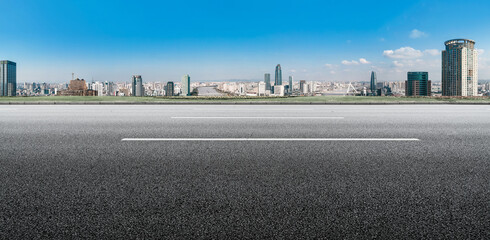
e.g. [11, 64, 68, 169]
[0, 0, 490, 82]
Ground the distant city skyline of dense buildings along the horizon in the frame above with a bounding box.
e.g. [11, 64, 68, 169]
[9, 49, 489, 97]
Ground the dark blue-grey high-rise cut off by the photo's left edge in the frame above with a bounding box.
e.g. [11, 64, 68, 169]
[0, 60, 17, 97]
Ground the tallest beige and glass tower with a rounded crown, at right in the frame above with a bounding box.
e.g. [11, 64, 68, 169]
[442, 39, 478, 96]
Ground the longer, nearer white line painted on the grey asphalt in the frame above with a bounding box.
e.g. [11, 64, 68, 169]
[121, 138, 420, 142]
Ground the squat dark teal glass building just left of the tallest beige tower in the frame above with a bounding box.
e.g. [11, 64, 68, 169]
[405, 72, 432, 96]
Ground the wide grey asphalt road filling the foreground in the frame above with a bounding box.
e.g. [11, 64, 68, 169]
[0, 105, 490, 239]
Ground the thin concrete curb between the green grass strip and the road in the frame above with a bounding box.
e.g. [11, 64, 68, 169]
[0, 101, 490, 105]
